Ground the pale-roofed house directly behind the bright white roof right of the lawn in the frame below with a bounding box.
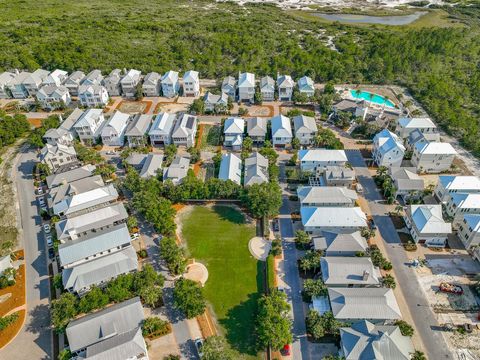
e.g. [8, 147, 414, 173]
[297, 186, 358, 207]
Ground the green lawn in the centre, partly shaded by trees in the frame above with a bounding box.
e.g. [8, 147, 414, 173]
[182, 206, 263, 358]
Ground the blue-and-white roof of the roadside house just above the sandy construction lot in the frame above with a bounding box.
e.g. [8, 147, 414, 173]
[409, 205, 452, 235]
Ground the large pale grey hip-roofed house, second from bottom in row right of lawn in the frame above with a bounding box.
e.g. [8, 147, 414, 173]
[328, 288, 402, 324]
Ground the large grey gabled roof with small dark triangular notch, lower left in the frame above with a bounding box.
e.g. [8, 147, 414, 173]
[66, 297, 144, 352]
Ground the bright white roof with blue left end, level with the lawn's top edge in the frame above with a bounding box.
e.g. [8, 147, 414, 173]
[300, 206, 367, 228]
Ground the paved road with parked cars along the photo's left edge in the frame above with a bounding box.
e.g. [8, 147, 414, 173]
[0, 147, 52, 360]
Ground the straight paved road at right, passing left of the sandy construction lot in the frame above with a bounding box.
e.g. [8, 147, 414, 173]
[346, 150, 453, 360]
